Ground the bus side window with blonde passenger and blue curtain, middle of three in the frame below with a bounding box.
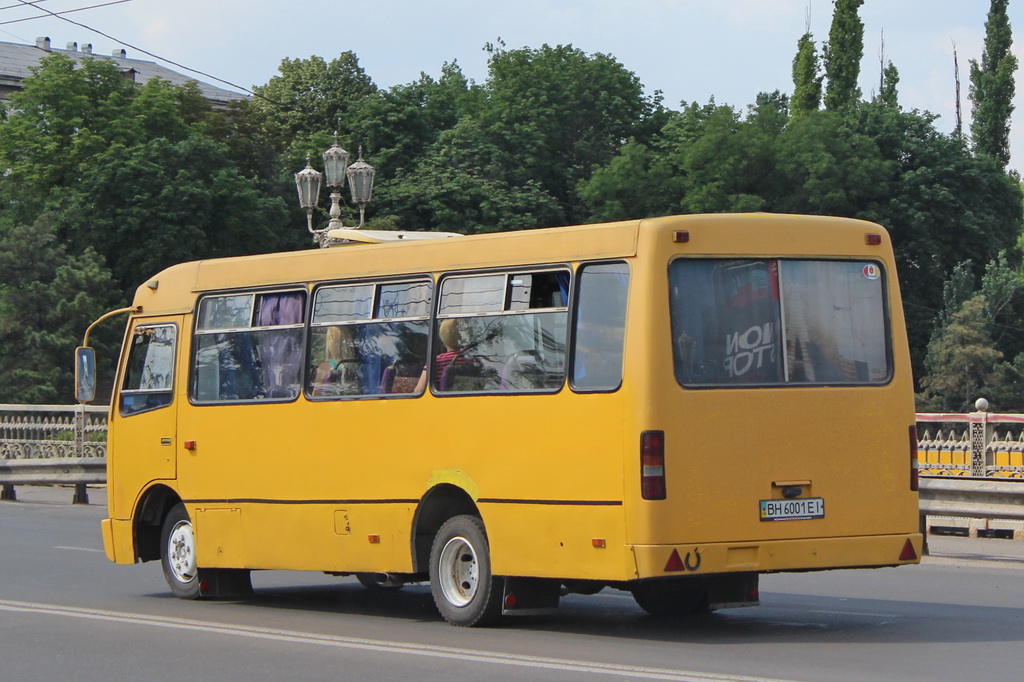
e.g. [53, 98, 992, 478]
[306, 281, 432, 397]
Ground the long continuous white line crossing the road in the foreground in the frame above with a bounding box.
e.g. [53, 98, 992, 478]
[0, 599, 779, 682]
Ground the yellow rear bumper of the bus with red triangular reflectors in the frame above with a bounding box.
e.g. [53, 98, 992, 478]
[633, 532, 922, 579]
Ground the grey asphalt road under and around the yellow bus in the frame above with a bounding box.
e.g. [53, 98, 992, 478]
[0, 487, 1024, 682]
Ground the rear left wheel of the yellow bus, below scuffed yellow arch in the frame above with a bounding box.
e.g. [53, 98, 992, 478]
[430, 516, 504, 628]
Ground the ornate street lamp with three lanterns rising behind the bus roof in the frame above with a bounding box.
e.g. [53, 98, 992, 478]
[295, 133, 377, 247]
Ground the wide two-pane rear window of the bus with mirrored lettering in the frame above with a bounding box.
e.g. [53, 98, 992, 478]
[669, 259, 892, 386]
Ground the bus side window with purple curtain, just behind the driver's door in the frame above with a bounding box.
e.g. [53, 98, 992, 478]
[193, 291, 305, 402]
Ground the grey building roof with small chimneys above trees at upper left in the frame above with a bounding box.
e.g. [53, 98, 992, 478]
[0, 38, 247, 105]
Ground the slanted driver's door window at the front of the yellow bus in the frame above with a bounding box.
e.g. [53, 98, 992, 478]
[119, 325, 177, 417]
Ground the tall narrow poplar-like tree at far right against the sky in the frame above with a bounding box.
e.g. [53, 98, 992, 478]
[970, 0, 1017, 167]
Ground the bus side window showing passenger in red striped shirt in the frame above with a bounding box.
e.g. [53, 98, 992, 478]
[432, 270, 569, 392]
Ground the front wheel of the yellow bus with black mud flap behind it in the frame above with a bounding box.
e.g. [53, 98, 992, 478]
[160, 503, 252, 599]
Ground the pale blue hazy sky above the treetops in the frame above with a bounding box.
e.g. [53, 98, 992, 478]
[0, 0, 1024, 168]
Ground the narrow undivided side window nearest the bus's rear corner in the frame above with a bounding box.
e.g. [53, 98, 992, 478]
[571, 263, 630, 392]
